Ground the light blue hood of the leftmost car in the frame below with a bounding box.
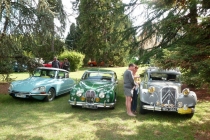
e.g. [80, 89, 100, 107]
[12, 77, 55, 92]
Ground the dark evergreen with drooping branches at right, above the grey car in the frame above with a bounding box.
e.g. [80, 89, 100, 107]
[135, 0, 210, 83]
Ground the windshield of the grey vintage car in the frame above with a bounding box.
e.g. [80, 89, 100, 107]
[149, 72, 180, 82]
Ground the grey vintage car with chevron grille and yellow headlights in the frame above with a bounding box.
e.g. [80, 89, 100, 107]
[140, 67, 197, 117]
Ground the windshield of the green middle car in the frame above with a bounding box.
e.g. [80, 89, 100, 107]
[83, 72, 113, 80]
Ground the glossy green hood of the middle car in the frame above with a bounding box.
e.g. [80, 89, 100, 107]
[76, 80, 112, 90]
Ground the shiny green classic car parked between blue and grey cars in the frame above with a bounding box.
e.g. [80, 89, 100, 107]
[69, 69, 118, 109]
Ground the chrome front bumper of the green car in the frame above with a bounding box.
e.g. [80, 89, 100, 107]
[68, 100, 115, 109]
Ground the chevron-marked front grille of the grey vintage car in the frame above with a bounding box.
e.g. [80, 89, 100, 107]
[162, 87, 176, 105]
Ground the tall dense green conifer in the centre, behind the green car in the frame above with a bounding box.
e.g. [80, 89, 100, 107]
[72, 0, 135, 65]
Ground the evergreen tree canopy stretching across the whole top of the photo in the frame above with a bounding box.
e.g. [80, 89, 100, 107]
[0, 0, 210, 83]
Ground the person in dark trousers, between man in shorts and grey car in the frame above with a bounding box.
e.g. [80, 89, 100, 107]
[131, 66, 140, 113]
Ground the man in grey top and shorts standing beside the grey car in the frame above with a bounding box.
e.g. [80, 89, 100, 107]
[123, 64, 136, 116]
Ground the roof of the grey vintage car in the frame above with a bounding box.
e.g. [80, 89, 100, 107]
[146, 67, 181, 74]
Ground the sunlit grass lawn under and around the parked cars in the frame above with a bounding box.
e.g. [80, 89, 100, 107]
[0, 68, 210, 140]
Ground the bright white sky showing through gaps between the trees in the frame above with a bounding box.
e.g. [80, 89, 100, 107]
[60, 0, 144, 38]
